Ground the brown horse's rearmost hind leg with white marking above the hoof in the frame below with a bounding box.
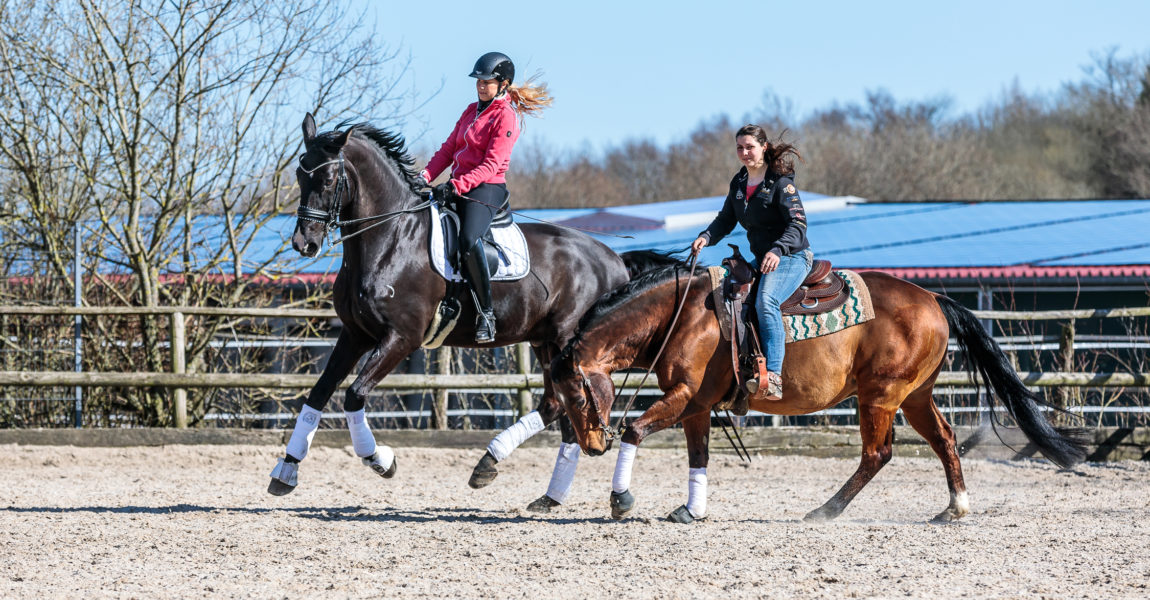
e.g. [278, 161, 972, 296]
[903, 377, 971, 523]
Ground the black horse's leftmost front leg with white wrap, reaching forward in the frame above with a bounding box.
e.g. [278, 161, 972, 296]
[268, 329, 366, 495]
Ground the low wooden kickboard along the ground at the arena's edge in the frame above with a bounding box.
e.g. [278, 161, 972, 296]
[0, 426, 1150, 461]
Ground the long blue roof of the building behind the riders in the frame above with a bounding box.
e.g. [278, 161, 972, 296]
[83, 193, 1150, 274]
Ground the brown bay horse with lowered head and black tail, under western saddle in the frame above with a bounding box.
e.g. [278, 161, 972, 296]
[551, 254, 1086, 523]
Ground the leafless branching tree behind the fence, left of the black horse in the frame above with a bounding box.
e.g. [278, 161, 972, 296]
[0, 0, 430, 424]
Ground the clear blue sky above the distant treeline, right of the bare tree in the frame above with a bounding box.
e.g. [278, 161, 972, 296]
[360, 0, 1150, 152]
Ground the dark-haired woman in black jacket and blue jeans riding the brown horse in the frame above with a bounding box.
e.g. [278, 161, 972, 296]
[691, 125, 813, 399]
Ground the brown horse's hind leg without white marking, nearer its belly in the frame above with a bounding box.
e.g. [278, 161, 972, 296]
[803, 390, 897, 521]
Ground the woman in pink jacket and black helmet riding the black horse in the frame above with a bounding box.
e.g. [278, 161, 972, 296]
[420, 52, 551, 344]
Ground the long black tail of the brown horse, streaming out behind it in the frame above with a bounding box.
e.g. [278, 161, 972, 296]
[935, 295, 1086, 468]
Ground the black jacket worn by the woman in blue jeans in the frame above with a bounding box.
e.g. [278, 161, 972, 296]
[699, 167, 811, 263]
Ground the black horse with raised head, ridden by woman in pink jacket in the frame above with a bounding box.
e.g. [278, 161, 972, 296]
[268, 113, 629, 500]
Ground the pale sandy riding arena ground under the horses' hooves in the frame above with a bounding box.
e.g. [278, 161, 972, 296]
[0, 445, 1150, 599]
